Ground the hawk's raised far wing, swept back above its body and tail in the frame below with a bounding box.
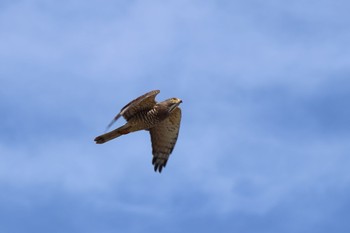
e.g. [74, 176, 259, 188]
[107, 90, 160, 129]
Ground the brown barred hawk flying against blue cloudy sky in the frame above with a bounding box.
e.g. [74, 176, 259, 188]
[94, 90, 182, 173]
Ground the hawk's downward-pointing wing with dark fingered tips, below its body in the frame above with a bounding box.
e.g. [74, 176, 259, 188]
[150, 107, 181, 172]
